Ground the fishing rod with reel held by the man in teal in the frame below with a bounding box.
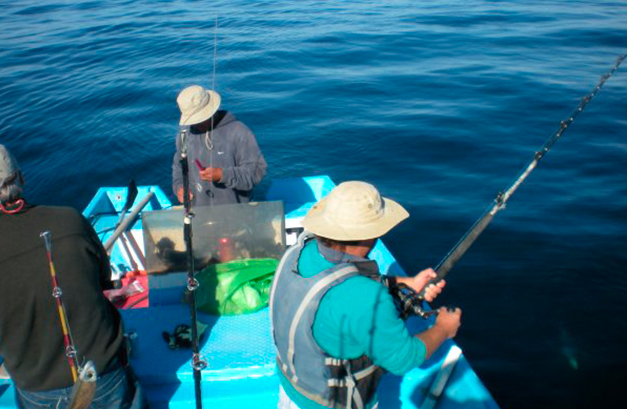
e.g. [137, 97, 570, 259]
[399, 54, 627, 318]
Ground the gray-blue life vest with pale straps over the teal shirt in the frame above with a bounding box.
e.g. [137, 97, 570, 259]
[270, 232, 383, 409]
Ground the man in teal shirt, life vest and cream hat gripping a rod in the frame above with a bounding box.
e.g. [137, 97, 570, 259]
[270, 182, 461, 409]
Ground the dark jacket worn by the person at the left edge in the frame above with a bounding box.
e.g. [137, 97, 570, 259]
[0, 206, 123, 391]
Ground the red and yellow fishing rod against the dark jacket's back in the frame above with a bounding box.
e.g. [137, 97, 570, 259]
[39, 231, 97, 409]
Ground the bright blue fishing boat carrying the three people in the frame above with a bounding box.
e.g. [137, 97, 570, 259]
[0, 176, 498, 409]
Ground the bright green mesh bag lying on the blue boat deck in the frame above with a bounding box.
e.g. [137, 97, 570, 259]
[196, 258, 279, 315]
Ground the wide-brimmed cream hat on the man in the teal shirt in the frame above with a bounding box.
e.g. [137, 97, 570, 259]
[303, 182, 409, 241]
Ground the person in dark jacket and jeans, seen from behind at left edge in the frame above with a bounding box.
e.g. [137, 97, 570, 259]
[0, 145, 147, 409]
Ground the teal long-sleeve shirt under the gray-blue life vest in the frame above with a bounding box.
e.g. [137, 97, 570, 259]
[279, 240, 426, 409]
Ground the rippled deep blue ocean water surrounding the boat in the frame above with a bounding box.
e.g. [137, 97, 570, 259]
[0, 0, 627, 408]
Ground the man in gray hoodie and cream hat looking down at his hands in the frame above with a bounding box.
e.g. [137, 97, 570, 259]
[172, 85, 268, 206]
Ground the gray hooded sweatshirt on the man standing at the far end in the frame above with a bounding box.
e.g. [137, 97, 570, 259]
[172, 111, 268, 206]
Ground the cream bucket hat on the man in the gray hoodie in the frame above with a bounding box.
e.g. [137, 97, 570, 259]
[176, 85, 222, 125]
